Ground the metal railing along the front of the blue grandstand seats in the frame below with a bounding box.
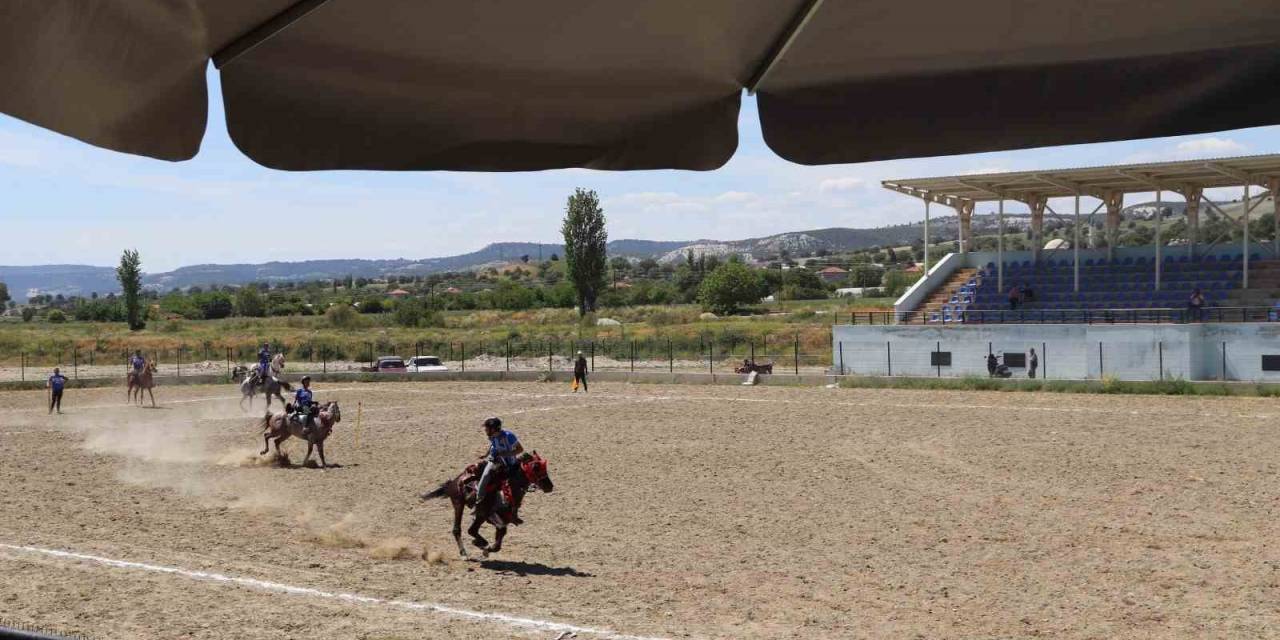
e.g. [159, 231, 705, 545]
[849, 307, 1280, 325]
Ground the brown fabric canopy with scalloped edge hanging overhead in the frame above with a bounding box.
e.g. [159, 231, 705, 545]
[0, 0, 1280, 170]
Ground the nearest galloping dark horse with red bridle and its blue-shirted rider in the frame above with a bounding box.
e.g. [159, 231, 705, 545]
[421, 417, 554, 557]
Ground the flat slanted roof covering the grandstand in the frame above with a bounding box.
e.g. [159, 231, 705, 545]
[881, 154, 1280, 205]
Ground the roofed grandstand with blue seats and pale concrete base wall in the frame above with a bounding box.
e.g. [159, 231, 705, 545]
[832, 155, 1280, 381]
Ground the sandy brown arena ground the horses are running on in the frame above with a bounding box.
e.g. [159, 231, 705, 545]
[0, 383, 1280, 639]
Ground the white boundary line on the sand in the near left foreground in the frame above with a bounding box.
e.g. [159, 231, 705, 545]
[0, 543, 666, 640]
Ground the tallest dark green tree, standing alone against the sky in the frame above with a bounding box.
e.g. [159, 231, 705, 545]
[552, 188, 609, 315]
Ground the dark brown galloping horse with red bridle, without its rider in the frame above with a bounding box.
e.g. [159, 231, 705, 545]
[420, 451, 556, 558]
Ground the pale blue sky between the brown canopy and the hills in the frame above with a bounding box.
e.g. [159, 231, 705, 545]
[0, 68, 1280, 271]
